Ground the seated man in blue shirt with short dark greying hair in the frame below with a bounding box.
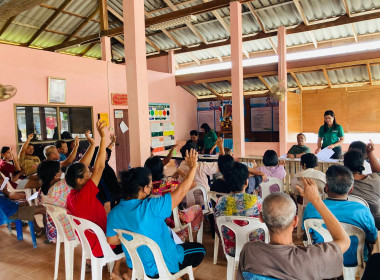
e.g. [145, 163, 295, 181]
[302, 165, 377, 266]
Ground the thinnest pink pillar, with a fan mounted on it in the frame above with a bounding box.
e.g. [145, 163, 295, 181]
[277, 26, 288, 155]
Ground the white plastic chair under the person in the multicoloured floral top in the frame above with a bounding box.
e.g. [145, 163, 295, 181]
[216, 216, 269, 280]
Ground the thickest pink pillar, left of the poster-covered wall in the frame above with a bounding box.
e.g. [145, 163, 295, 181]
[123, 0, 151, 168]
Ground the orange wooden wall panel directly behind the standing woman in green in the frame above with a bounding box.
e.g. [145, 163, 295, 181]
[302, 88, 348, 133]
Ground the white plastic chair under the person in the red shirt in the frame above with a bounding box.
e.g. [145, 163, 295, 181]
[67, 215, 125, 280]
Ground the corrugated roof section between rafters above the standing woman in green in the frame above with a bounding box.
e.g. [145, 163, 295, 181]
[327, 66, 369, 85]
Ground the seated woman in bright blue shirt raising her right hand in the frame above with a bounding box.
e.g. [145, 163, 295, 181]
[107, 150, 206, 278]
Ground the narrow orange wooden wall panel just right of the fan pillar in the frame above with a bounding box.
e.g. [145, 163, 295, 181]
[287, 92, 301, 142]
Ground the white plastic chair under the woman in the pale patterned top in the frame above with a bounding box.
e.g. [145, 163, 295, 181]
[43, 203, 83, 280]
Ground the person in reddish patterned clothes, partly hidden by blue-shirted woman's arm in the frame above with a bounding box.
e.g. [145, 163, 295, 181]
[144, 157, 203, 240]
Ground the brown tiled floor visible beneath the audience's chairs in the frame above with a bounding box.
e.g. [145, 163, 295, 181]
[0, 218, 300, 280]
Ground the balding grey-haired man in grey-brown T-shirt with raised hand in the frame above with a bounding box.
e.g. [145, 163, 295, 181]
[237, 179, 350, 280]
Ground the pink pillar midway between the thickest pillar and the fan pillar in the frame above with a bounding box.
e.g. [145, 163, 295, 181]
[230, 1, 245, 157]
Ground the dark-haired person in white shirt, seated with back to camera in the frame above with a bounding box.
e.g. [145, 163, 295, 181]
[291, 153, 326, 196]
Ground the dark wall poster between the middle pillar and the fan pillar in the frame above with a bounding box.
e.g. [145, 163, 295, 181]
[250, 97, 279, 132]
